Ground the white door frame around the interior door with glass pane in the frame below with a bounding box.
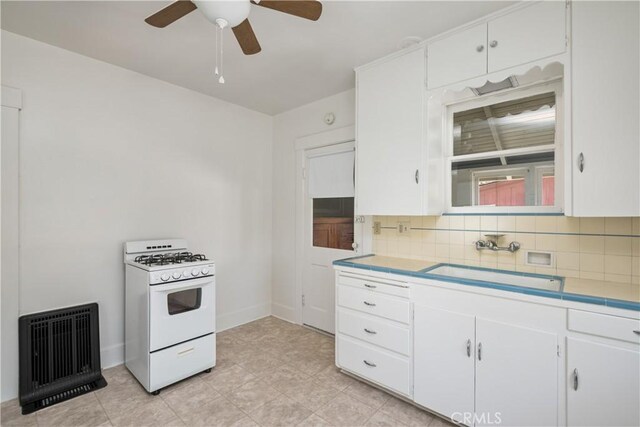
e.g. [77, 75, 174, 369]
[294, 126, 371, 325]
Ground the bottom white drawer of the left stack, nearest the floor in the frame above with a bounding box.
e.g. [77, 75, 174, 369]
[338, 335, 410, 395]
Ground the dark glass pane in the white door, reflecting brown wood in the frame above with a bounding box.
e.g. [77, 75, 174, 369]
[312, 197, 354, 251]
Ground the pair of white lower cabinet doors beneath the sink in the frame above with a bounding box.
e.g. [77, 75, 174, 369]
[414, 305, 558, 426]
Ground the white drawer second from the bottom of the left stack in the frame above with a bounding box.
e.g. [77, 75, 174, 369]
[338, 308, 410, 356]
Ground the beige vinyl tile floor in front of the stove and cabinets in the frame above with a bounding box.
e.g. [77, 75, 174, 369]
[0, 317, 450, 427]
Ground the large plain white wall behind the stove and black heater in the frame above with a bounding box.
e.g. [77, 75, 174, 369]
[2, 31, 272, 400]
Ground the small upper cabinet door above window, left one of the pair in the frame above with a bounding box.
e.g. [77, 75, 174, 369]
[427, 24, 487, 89]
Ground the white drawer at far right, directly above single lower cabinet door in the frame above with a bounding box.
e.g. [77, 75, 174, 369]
[569, 310, 640, 343]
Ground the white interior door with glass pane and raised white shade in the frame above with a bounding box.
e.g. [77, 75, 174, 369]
[302, 142, 361, 334]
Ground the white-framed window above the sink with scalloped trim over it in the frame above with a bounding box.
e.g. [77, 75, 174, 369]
[447, 82, 562, 212]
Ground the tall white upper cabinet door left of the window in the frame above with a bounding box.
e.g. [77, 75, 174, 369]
[356, 49, 425, 215]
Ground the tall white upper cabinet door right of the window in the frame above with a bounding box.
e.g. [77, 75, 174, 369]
[567, 2, 640, 216]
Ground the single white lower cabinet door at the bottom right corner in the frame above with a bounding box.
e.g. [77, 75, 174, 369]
[567, 338, 640, 426]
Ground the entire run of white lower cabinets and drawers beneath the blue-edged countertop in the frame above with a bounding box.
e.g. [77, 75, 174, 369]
[336, 271, 640, 427]
